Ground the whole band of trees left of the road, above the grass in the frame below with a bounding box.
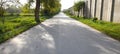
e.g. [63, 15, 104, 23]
[0, 0, 61, 23]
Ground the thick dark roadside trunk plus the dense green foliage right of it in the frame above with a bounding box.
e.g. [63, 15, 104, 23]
[35, 0, 61, 23]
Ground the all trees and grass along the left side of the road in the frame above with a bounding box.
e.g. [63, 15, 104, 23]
[0, 0, 61, 43]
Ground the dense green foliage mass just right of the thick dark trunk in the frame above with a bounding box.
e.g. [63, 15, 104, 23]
[42, 0, 61, 15]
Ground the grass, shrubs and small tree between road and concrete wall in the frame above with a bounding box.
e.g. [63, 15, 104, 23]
[63, 1, 120, 41]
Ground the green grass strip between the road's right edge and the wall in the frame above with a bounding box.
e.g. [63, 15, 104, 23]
[65, 15, 120, 41]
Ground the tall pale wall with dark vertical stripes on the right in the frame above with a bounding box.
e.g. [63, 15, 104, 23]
[85, 0, 120, 23]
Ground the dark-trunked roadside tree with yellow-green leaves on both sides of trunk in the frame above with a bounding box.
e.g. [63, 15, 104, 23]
[25, 0, 61, 23]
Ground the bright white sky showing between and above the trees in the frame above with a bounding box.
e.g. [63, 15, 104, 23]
[20, 0, 80, 10]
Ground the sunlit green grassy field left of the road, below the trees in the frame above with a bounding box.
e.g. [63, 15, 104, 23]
[0, 16, 46, 43]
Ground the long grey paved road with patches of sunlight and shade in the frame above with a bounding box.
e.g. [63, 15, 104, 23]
[0, 13, 120, 54]
